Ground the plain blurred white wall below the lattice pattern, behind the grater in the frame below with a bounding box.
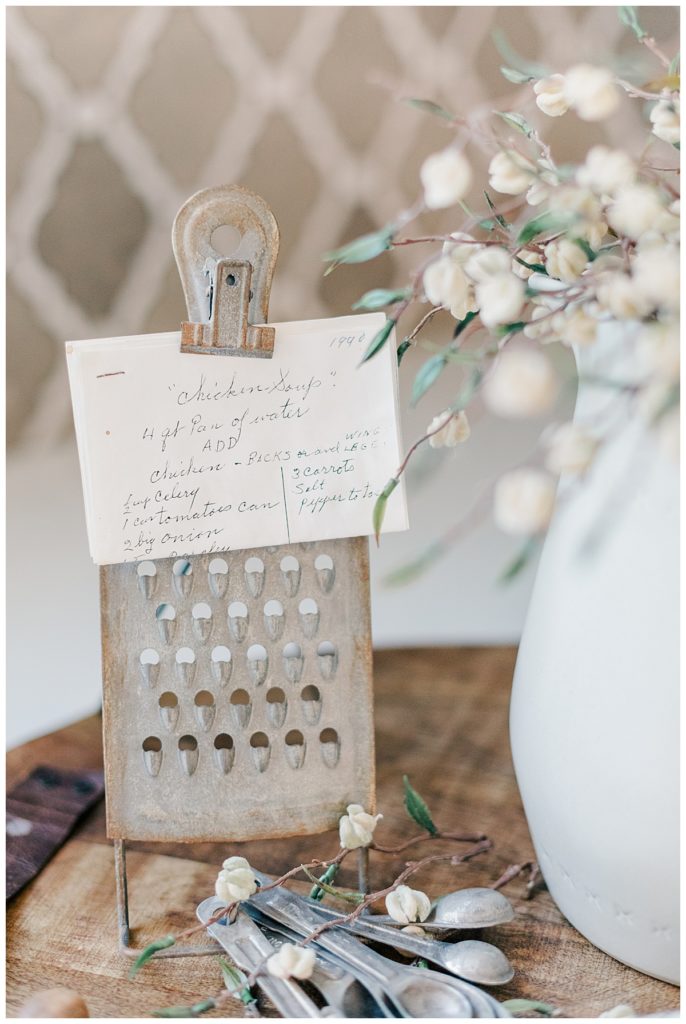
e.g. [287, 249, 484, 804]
[7, 344, 569, 745]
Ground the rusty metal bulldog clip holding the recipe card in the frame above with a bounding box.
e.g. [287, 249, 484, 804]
[172, 185, 278, 358]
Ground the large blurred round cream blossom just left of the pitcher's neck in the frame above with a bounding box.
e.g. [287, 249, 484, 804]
[481, 347, 558, 420]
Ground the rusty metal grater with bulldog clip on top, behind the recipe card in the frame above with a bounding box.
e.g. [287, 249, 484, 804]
[100, 186, 374, 952]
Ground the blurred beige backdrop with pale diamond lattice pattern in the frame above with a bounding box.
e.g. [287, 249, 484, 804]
[8, 7, 677, 450]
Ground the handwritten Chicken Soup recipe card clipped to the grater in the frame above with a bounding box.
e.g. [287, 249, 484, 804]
[67, 313, 408, 565]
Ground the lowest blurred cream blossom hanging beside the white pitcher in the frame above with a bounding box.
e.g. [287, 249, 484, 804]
[494, 468, 555, 537]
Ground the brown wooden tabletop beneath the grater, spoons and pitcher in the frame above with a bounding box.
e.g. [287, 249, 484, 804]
[7, 647, 679, 1017]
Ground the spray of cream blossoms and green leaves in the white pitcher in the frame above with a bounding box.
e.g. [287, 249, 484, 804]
[329, 7, 680, 582]
